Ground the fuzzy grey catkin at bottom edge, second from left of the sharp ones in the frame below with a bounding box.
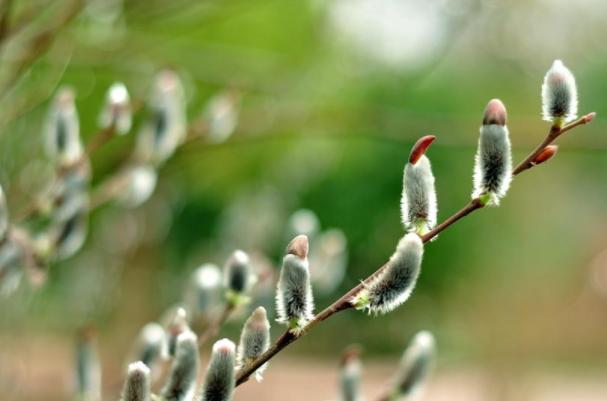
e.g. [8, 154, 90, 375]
[160, 331, 200, 401]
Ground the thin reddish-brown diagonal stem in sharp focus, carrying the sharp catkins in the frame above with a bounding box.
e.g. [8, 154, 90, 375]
[236, 113, 595, 386]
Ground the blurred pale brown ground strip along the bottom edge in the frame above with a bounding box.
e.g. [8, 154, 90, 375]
[0, 338, 607, 401]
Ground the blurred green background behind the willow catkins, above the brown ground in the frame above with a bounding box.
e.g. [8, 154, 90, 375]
[0, 0, 607, 401]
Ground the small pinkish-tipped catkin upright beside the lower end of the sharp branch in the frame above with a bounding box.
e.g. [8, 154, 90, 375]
[236, 306, 270, 381]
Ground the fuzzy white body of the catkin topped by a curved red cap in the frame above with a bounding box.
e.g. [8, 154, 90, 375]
[401, 155, 437, 234]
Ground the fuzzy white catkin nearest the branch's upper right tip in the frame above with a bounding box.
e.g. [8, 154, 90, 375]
[542, 60, 578, 125]
